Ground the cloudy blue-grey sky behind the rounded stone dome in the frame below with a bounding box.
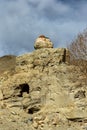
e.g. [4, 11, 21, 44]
[0, 0, 87, 56]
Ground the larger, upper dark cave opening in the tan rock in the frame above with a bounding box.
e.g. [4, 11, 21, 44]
[19, 83, 29, 97]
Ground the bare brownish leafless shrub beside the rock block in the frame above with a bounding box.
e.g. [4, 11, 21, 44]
[68, 30, 87, 76]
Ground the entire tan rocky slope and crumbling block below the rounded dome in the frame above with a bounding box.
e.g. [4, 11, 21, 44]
[0, 45, 87, 130]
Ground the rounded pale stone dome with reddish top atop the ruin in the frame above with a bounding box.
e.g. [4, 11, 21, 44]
[34, 35, 53, 49]
